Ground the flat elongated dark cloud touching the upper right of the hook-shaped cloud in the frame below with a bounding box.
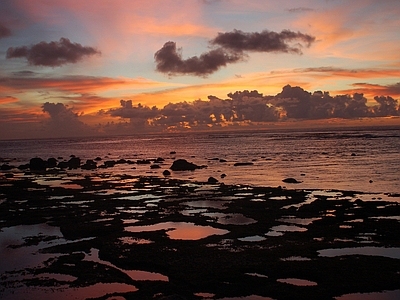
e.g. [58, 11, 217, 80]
[210, 29, 315, 54]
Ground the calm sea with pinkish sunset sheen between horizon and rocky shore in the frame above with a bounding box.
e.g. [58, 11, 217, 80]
[0, 127, 400, 193]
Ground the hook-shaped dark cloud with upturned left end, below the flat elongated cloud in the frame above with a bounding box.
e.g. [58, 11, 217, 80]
[154, 42, 243, 76]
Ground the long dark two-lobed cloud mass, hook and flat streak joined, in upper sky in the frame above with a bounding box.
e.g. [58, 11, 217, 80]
[154, 30, 315, 76]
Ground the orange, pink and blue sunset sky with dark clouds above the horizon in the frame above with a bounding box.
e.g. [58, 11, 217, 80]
[0, 0, 400, 139]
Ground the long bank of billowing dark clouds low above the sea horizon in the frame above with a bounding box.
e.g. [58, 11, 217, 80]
[103, 85, 400, 131]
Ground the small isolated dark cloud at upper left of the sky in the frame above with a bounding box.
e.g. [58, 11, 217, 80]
[7, 38, 100, 67]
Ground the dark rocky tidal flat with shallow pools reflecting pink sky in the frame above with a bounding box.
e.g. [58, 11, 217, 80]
[0, 171, 400, 300]
